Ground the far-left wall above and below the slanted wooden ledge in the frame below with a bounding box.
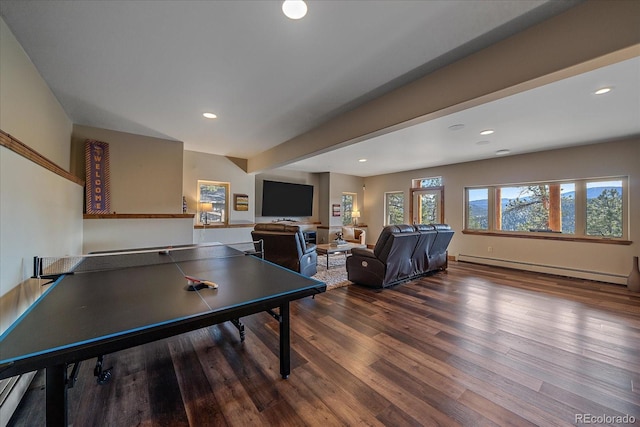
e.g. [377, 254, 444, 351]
[0, 18, 83, 425]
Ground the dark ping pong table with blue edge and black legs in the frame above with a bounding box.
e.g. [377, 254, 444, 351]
[0, 245, 326, 426]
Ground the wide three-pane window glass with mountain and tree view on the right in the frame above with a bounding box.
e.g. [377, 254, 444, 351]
[465, 178, 627, 238]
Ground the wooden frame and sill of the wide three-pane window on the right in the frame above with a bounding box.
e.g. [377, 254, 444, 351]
[462, 176, 632, 245]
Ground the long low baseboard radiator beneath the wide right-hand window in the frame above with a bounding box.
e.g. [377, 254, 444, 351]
[456, 254, 627, 285]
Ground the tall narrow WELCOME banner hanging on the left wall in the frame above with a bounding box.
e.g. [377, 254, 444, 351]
[84, 139, 111, 214]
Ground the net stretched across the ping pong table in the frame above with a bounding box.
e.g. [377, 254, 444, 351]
[33, 240, 264, 279]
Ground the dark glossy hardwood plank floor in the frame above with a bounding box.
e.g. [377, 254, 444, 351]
[10, 262, 640, 427]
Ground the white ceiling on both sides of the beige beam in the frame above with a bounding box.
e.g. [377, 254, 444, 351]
[0, 0, 640, 176]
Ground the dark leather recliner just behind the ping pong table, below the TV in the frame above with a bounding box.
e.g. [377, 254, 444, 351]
[251, 223, 318, 277]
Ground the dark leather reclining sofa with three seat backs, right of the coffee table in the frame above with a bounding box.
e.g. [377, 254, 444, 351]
[347, 224, 454, 288]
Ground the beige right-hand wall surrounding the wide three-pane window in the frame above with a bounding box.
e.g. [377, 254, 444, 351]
[364, 138, 640, 283]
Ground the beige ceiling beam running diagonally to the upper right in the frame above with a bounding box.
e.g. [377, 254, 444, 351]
[247, 0, 640, 173]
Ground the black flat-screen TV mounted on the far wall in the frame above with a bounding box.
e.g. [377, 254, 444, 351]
[262, 181, 313, 217]
